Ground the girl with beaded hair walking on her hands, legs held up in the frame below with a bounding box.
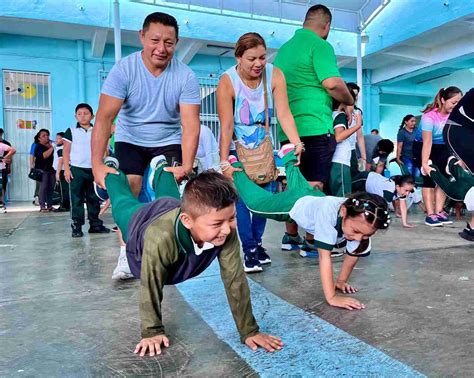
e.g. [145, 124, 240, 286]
[229, 145, 390, 310]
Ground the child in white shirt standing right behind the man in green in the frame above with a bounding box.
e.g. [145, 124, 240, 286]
[329, 89, 362, 197]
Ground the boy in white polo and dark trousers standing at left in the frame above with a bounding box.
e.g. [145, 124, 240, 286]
[63, 103, 110, 238]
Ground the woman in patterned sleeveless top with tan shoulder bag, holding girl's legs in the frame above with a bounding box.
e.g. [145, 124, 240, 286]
[217, 33, 303, 272]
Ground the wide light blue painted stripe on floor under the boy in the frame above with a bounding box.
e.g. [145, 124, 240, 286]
[177, 262, 423, 377]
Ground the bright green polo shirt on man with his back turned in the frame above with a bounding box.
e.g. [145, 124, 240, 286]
[274, 29, 341, 141]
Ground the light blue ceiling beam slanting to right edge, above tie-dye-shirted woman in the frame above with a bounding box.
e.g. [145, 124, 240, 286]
[372, 35, 474, 84]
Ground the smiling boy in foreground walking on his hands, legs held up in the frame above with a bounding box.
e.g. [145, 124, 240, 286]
[101, 155, 283, 356]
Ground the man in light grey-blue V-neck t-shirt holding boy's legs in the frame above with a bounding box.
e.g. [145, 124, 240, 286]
[92, 12, 201, 278]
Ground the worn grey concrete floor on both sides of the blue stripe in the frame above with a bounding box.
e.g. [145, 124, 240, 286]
[0, 205, 474, 376]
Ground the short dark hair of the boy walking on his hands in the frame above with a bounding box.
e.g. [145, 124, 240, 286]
[181, 170, 239, 217]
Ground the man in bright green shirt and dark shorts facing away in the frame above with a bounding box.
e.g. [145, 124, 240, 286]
[274, 4, 354, 254]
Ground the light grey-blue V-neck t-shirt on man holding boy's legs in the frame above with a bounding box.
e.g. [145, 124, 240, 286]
[102, 51, 201, 147]
